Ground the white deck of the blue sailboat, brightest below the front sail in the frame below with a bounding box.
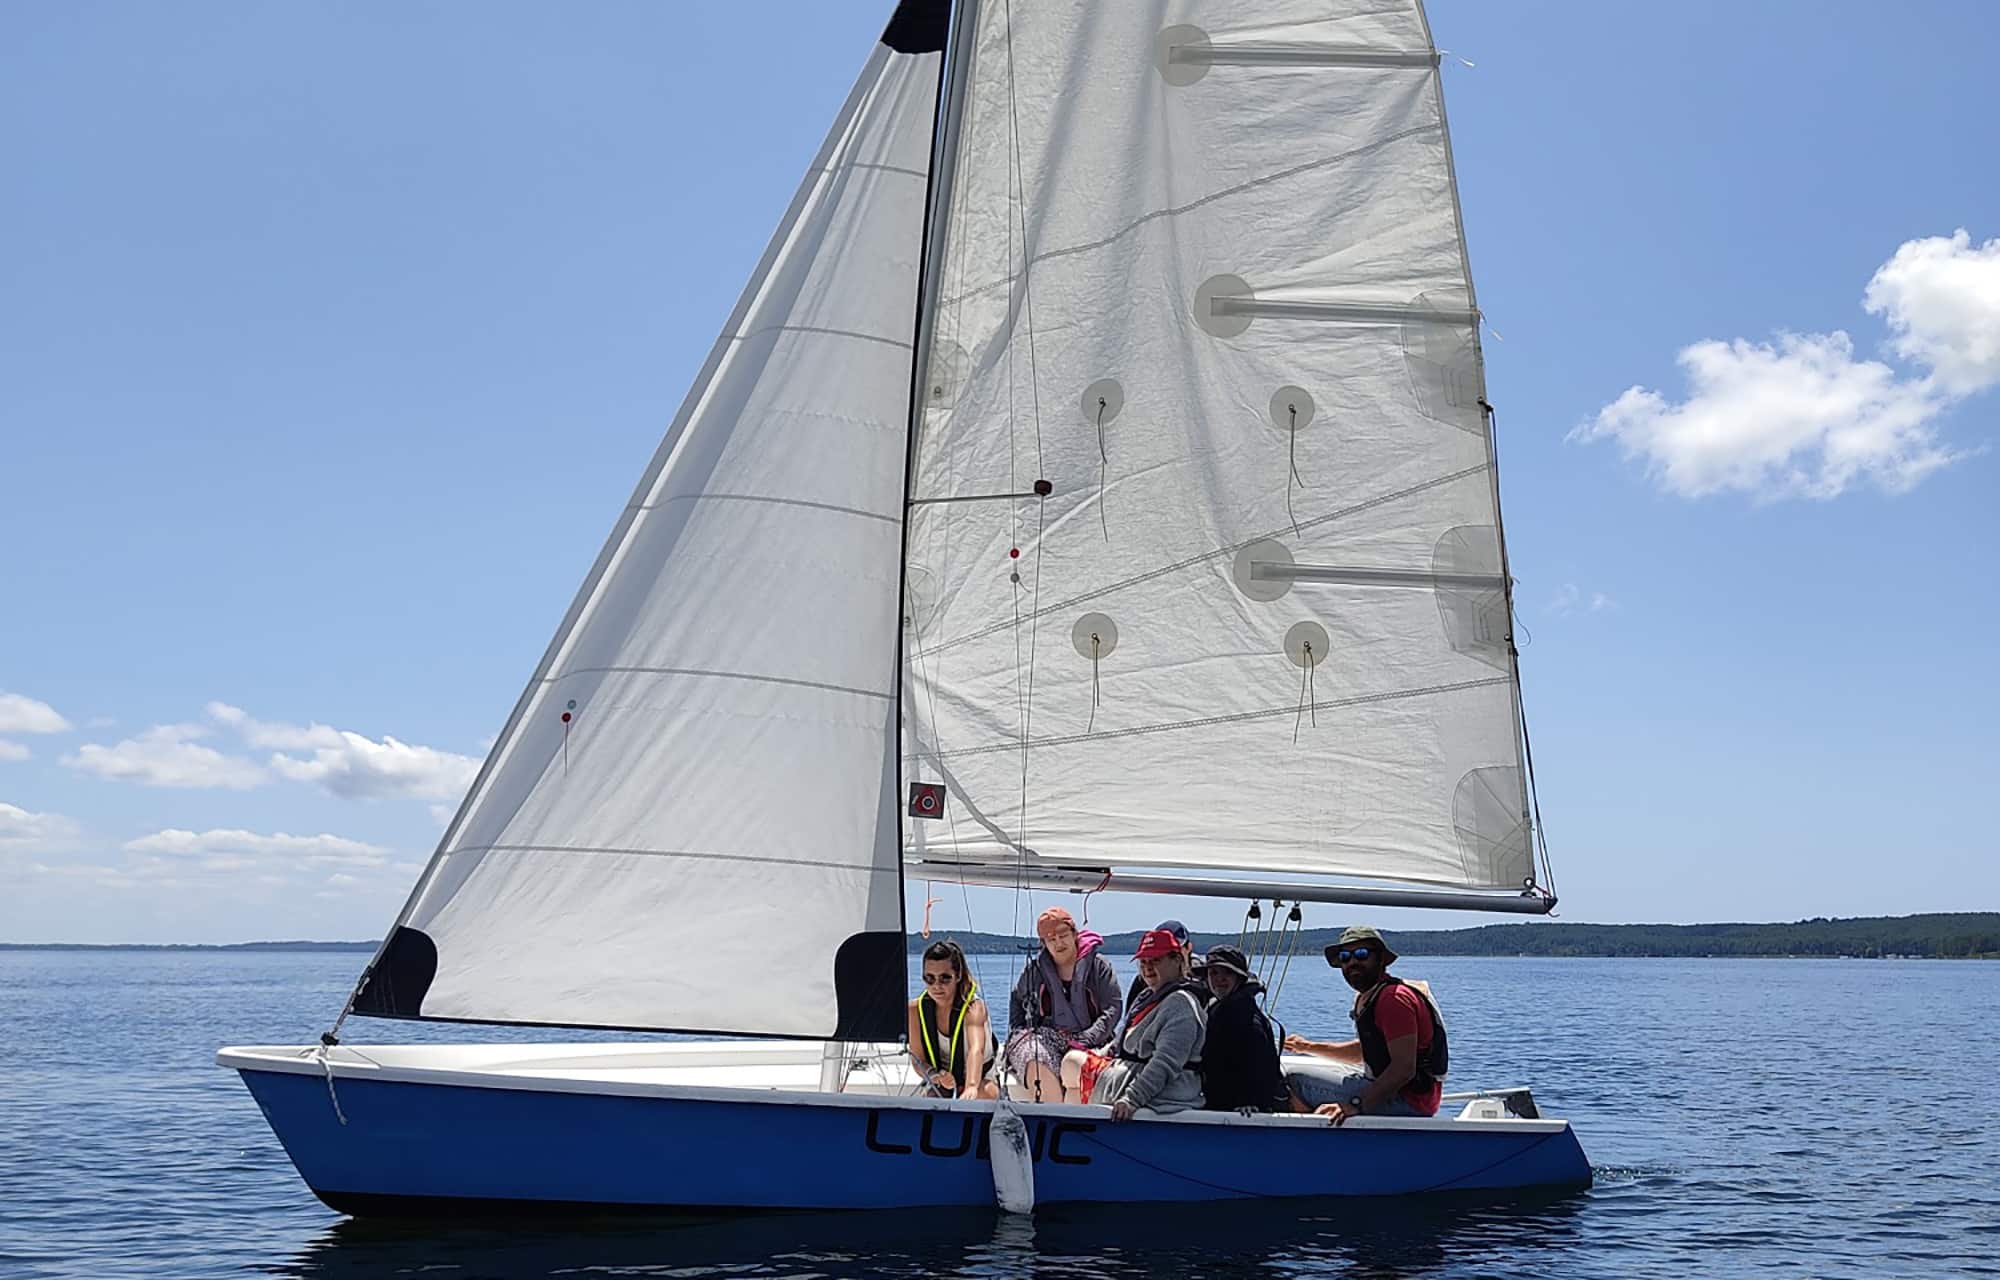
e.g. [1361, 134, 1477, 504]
[216, 1040, 1568, 1132]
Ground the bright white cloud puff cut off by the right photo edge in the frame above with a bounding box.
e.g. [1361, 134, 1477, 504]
[1862, 228, 2000, 394]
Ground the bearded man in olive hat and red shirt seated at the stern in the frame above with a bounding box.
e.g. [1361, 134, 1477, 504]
[1284, 924, 1448, 1124]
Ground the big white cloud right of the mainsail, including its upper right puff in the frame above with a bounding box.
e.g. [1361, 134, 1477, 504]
[1570, 232, 2000, 500]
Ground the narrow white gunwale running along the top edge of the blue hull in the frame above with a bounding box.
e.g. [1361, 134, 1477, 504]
[216, 1044, 1570, 1136]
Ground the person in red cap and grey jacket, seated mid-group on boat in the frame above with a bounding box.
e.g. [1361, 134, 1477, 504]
[1078, 928, 1208, 1120]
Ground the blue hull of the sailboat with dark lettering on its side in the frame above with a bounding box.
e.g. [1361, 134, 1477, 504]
[242, 1070, 1590, 1214]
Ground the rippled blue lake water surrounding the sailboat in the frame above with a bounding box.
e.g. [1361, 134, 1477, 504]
[0, 952, 2000, 1280]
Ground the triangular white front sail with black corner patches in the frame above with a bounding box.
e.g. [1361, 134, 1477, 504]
[354, 0, 944, 1038]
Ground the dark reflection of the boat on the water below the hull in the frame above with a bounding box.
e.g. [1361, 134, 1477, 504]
[268, 1192, 1588, 1280]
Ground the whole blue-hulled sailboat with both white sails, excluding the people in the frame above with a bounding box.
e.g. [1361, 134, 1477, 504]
[218, 0, 1590, 1214]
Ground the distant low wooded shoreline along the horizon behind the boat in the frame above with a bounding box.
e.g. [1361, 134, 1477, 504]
[0, 912, 2000, 960]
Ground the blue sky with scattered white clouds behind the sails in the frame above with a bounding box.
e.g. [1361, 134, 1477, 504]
[0, 0, 2000, 940]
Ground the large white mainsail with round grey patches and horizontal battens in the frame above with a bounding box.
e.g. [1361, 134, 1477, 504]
[904, 0, 1534, 892]
